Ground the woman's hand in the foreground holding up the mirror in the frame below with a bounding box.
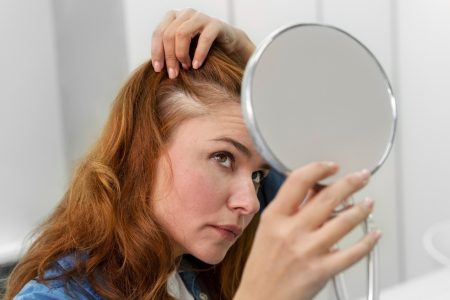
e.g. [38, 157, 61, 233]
[235, 162, 380, 300]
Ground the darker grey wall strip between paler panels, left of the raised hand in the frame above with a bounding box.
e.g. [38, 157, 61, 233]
[54, 0, 128, 165]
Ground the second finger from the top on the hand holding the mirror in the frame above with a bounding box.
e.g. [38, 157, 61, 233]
[298, 170, 370, 229]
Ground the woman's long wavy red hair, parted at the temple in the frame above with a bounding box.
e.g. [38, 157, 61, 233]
[5, 45, 258, 299]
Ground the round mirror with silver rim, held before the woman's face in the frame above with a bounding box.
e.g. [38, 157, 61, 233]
[242, 24, 396, 184]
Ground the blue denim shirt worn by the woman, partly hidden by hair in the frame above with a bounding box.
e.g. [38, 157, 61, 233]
[14, 170, 284, 300]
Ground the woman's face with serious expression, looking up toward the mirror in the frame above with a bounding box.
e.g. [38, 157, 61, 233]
[153, 103, 268, 264]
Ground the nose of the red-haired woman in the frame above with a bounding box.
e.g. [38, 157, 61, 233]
[228, 177, 259, 215]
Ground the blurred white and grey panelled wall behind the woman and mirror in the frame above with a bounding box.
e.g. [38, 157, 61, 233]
[0, 0, 450, 299]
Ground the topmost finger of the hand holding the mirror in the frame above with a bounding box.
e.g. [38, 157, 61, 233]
[266, 162, 338, 215]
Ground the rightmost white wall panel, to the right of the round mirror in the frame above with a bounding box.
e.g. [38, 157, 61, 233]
[397, 0, 450, 278]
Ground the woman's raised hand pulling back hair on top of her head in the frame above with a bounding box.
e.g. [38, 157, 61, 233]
[151, 9, 255, 78]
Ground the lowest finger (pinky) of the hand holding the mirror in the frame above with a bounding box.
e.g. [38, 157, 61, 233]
[322, 231, 381, 275]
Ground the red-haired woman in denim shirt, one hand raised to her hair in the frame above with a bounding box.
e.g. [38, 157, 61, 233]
[6, 10, 379, 299]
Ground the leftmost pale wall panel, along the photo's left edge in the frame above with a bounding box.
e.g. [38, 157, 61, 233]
[0, 0, 67, 264]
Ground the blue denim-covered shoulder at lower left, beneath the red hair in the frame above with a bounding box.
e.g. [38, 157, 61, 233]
[14, 256, 102, 300]
